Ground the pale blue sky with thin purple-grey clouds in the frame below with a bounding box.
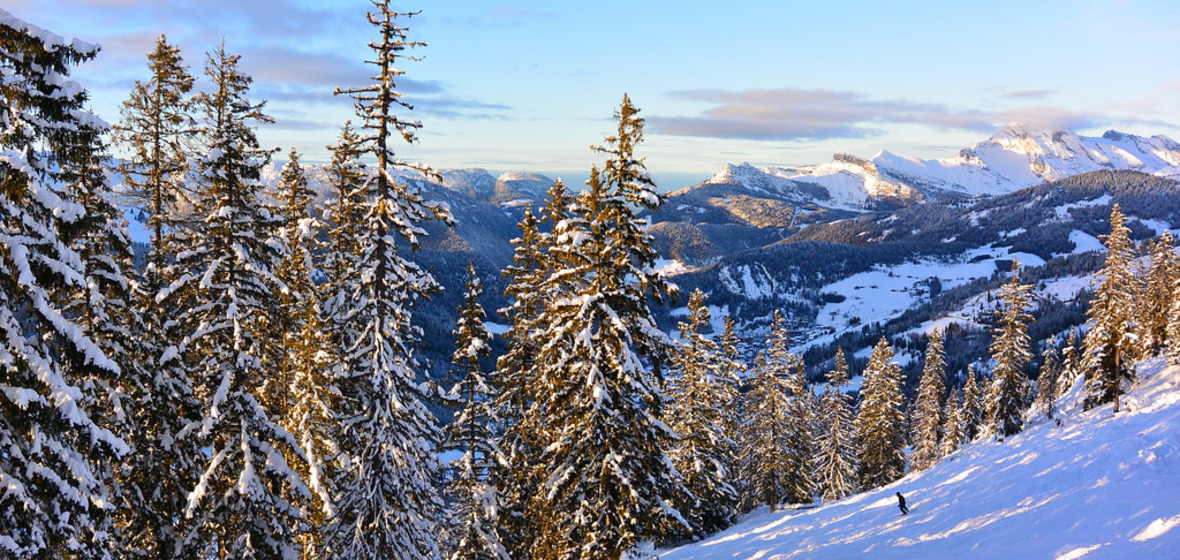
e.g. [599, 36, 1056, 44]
[5, 0, 1180, 189]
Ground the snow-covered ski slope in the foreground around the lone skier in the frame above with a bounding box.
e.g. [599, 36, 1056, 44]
[657, 360, 1180, 560]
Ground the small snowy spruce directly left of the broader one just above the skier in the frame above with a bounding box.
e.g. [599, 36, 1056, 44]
[815, 348, 859, 501]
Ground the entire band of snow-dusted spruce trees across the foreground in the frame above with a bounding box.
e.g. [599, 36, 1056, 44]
[0, 0, 1180, 560]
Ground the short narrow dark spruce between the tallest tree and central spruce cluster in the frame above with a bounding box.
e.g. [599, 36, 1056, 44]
[441, 264, 510, 560]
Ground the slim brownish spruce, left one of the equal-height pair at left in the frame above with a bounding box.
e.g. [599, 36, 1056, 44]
[113, 35, 203, 559]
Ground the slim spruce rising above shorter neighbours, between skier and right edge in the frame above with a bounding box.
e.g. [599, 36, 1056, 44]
[986, 259, 1033, 441]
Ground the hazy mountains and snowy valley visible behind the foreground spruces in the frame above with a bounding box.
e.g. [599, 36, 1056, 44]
[145, 125, 1180, 384]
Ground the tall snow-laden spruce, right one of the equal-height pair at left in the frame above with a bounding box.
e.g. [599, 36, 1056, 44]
[160, 45, 309, 558]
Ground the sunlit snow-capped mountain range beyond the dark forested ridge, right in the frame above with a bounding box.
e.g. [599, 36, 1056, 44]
[653, 125, 1180, 265]
